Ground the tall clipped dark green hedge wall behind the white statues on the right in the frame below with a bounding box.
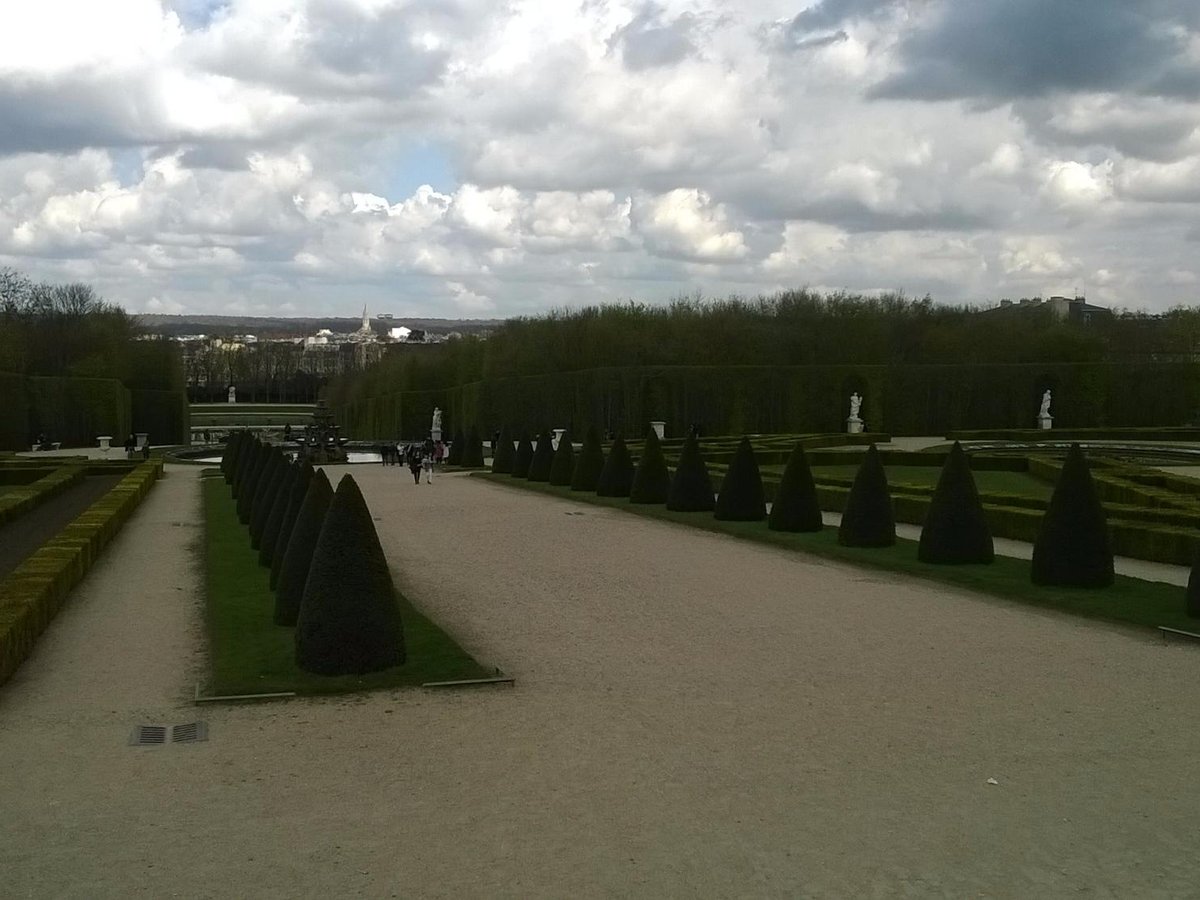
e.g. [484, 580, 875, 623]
[335, 362, 1200, 438]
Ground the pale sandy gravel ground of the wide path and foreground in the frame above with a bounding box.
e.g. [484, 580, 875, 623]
[0, 467, 1200, 898]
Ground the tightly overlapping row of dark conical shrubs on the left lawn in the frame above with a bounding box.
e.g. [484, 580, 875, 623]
[221, 432, 406, 676]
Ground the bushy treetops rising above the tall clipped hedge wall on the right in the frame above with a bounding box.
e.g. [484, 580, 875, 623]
[331, 289, 1200, 397]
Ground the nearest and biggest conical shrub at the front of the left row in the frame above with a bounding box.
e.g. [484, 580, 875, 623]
[295, 475, 404, 676]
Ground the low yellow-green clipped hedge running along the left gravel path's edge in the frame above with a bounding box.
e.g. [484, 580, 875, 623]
[0, 460, 162, 684]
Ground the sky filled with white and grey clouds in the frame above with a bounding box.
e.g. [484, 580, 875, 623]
[0, 0, 1200, 317]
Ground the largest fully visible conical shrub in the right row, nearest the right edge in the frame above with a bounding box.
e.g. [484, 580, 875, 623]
[1031, 444, 1112, 588]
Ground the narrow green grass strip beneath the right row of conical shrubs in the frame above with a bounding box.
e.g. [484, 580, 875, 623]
[472, 473, 1200, 631]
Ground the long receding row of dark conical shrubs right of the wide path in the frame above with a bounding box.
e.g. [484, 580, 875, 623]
[497, 428, 1128, 595]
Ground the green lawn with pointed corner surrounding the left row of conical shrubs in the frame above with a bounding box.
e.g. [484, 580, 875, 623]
[202, 475, 494, 696]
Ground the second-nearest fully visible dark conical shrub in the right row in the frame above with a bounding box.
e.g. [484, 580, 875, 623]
[917, 440, 996, 564]
